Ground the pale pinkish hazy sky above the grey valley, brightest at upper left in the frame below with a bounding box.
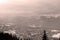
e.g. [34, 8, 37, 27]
[0, 0, 60, 16]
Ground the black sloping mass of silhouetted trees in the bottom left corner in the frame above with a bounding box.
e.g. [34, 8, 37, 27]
[0, 32, 19, 40]
